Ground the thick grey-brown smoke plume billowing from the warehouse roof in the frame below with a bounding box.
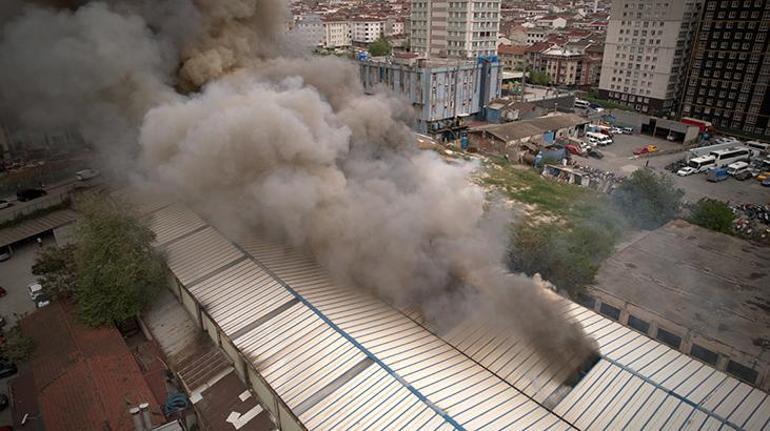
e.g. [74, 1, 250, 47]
[0, 0, 594, 374]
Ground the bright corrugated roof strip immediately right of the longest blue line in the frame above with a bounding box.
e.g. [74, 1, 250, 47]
[239, 237, 569, 429]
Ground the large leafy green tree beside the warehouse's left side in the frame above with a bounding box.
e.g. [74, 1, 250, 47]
[73, 199, 166, 326]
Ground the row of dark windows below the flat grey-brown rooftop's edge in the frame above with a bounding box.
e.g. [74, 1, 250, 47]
[599, 303, 759, 384]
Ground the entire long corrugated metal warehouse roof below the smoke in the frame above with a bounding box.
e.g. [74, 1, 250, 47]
[116, 193, 770, 430]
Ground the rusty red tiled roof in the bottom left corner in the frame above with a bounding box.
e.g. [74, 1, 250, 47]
[21, 302, 159, 431]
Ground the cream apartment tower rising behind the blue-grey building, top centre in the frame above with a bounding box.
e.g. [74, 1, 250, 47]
[410, 0, 500, 58]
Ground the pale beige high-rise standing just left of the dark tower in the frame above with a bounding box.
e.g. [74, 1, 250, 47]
[599, 0, 702, 116]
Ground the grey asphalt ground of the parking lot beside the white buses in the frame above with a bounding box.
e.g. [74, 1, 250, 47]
[575, 134, 770, 204]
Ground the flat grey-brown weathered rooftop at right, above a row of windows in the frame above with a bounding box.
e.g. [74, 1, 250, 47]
[591, 220, 770, 356]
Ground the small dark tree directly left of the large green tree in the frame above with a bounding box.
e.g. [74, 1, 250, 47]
[32, 245, 77, 298]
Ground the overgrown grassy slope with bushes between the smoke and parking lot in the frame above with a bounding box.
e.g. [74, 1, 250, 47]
[481, 159, 627, 298]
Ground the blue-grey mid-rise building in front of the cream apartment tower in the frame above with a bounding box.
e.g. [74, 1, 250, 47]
[359, 57, 502, 134]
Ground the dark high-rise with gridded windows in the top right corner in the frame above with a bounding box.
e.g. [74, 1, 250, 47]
[681, 0, 770, 138]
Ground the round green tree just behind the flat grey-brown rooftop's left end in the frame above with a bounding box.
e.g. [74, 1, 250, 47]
[611, 169, 684, 229]
